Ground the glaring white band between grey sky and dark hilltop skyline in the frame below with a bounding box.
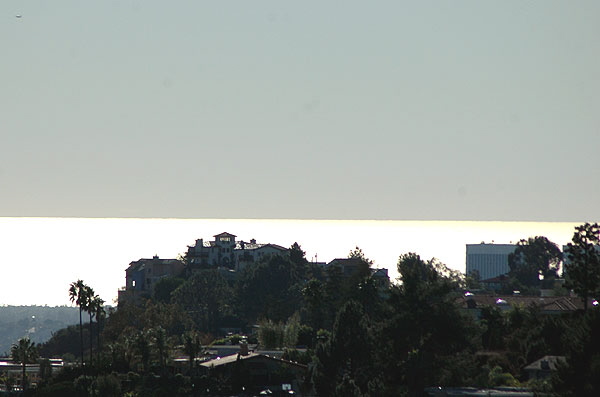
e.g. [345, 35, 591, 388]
[0, 218, 578, 306]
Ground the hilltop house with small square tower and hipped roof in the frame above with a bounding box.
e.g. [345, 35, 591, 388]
[186, 232, 288, 271]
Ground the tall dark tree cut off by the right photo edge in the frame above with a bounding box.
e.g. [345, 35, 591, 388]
[564, 223, 600, 310]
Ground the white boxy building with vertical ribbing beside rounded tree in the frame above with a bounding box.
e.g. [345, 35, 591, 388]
[466, 243, 517, 280]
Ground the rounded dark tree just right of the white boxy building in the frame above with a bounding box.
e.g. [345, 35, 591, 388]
[508, 236, 562, 287]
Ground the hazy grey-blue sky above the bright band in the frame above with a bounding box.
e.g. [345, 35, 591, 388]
[0, 0, 600, 221]
